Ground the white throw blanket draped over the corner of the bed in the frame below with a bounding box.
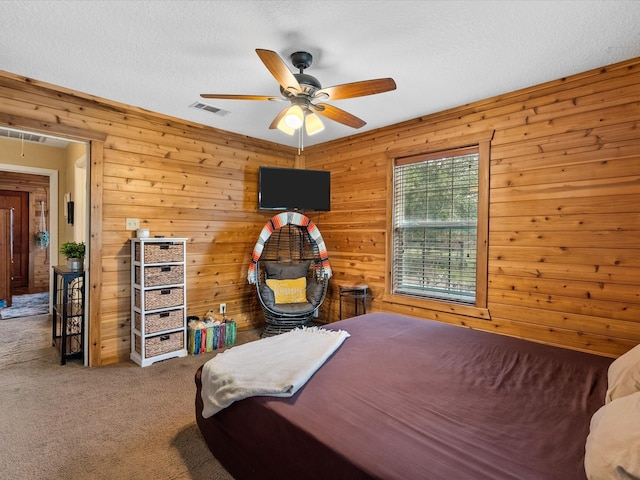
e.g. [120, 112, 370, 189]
[201, 327, 349, 418]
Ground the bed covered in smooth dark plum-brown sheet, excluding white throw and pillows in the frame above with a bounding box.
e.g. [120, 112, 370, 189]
[195, 313, 612, 480]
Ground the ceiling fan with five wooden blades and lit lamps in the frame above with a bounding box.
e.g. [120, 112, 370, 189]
[200, 49, 396, 135]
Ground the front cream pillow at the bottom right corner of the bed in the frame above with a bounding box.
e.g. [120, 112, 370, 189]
[584, 392, 640, 480]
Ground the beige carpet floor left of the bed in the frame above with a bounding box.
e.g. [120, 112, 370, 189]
[0, 315, 260, 480]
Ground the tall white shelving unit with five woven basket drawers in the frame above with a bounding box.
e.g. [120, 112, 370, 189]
[131, 238, 187, 367]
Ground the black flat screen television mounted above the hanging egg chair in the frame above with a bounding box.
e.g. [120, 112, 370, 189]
[258, 167, 331, 212]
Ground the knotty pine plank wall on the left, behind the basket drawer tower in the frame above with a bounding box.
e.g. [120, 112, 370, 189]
[0, 73, 296, 366]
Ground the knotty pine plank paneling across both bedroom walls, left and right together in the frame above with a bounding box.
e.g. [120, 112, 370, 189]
[0, 56, 640, 365]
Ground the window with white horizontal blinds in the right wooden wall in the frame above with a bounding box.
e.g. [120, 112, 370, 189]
[391, 146, 488, 306]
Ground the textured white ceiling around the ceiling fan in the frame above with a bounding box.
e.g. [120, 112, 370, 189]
[0, 0, 640, 146]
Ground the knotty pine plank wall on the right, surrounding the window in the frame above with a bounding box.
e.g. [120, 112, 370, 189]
[304, 59, 640, 356]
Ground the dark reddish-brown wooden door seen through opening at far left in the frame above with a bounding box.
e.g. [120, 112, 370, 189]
[0, 190, 29, 288]
